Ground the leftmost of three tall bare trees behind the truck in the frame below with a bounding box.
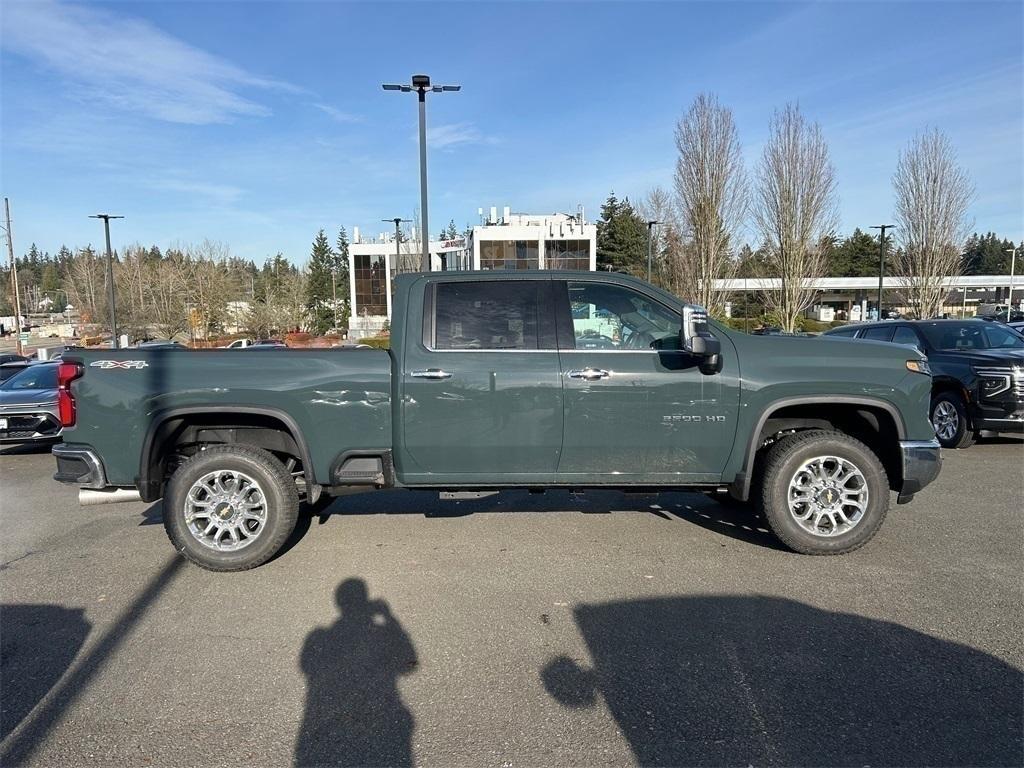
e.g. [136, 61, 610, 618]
[675, 93, 748, 312]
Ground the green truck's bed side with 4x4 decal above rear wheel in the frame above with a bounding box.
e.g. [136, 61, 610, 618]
[63, 348, 391, 485]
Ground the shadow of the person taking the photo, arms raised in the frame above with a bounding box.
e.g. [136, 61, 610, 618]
[295, 579, 417, 767]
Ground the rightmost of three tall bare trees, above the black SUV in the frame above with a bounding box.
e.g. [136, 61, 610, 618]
[893, 129, 974, 317]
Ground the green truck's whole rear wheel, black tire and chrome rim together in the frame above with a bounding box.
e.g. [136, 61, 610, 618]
[164, 445, 299, 570]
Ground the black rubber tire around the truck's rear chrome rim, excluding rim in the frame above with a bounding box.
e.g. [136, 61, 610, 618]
[164, 445, 299, 571]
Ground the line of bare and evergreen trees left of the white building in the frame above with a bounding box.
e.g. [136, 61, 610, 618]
[0, 227, 349, 339]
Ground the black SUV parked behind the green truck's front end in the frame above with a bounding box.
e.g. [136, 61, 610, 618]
[824, 319, 1024, 447]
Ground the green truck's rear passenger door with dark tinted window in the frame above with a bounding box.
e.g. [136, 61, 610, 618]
[399, 275, 562, 484]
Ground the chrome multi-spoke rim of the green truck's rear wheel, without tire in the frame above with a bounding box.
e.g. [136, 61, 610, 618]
[184, 469, 266, 552]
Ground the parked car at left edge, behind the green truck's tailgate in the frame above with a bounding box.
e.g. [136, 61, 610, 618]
[0, 361, 62, 442]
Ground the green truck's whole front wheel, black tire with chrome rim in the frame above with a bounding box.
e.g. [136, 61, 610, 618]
[761, 430, 889, 555]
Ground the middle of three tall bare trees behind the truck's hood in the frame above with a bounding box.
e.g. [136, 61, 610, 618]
[754, 104, 837, 332]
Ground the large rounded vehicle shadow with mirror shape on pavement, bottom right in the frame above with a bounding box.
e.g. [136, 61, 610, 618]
[541, 596, 1024, 766]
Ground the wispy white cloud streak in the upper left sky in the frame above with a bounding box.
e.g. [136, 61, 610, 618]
[0, 0, 300, 125]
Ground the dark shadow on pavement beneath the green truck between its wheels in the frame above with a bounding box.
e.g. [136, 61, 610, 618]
[307, 489, 788, 552]
